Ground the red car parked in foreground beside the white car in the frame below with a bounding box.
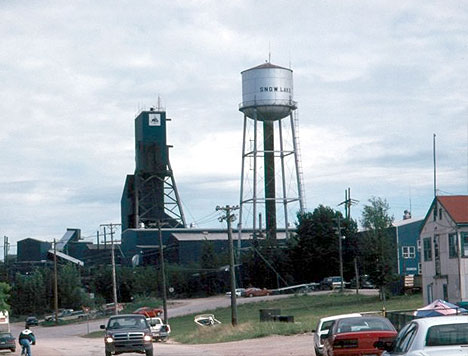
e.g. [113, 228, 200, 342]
[322, 316, 397, 356]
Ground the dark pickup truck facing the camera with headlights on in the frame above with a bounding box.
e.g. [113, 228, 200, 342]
[101, 314, 153, 356]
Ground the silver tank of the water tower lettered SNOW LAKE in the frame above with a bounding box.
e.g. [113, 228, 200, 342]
[239, 63, 296, 121]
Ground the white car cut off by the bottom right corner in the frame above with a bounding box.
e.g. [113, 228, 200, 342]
[376, 315, 468, 356]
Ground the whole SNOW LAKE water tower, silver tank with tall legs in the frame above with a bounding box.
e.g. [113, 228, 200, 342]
[239, 62, 304, 241]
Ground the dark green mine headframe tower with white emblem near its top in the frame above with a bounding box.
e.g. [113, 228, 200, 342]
[121, 107, 186, 231]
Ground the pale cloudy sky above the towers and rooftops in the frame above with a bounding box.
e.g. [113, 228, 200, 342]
[0, 0, 468, 251]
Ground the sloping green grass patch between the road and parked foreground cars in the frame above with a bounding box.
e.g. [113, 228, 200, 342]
[169, 293, 423, 344]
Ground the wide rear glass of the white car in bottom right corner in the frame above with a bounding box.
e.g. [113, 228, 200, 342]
[426, 323, 468, 346]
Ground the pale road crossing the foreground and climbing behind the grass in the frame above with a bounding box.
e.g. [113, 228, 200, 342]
[8, 292, 376, 356]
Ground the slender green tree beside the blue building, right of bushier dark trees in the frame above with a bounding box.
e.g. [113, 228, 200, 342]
[360, 197, 396, 298]
